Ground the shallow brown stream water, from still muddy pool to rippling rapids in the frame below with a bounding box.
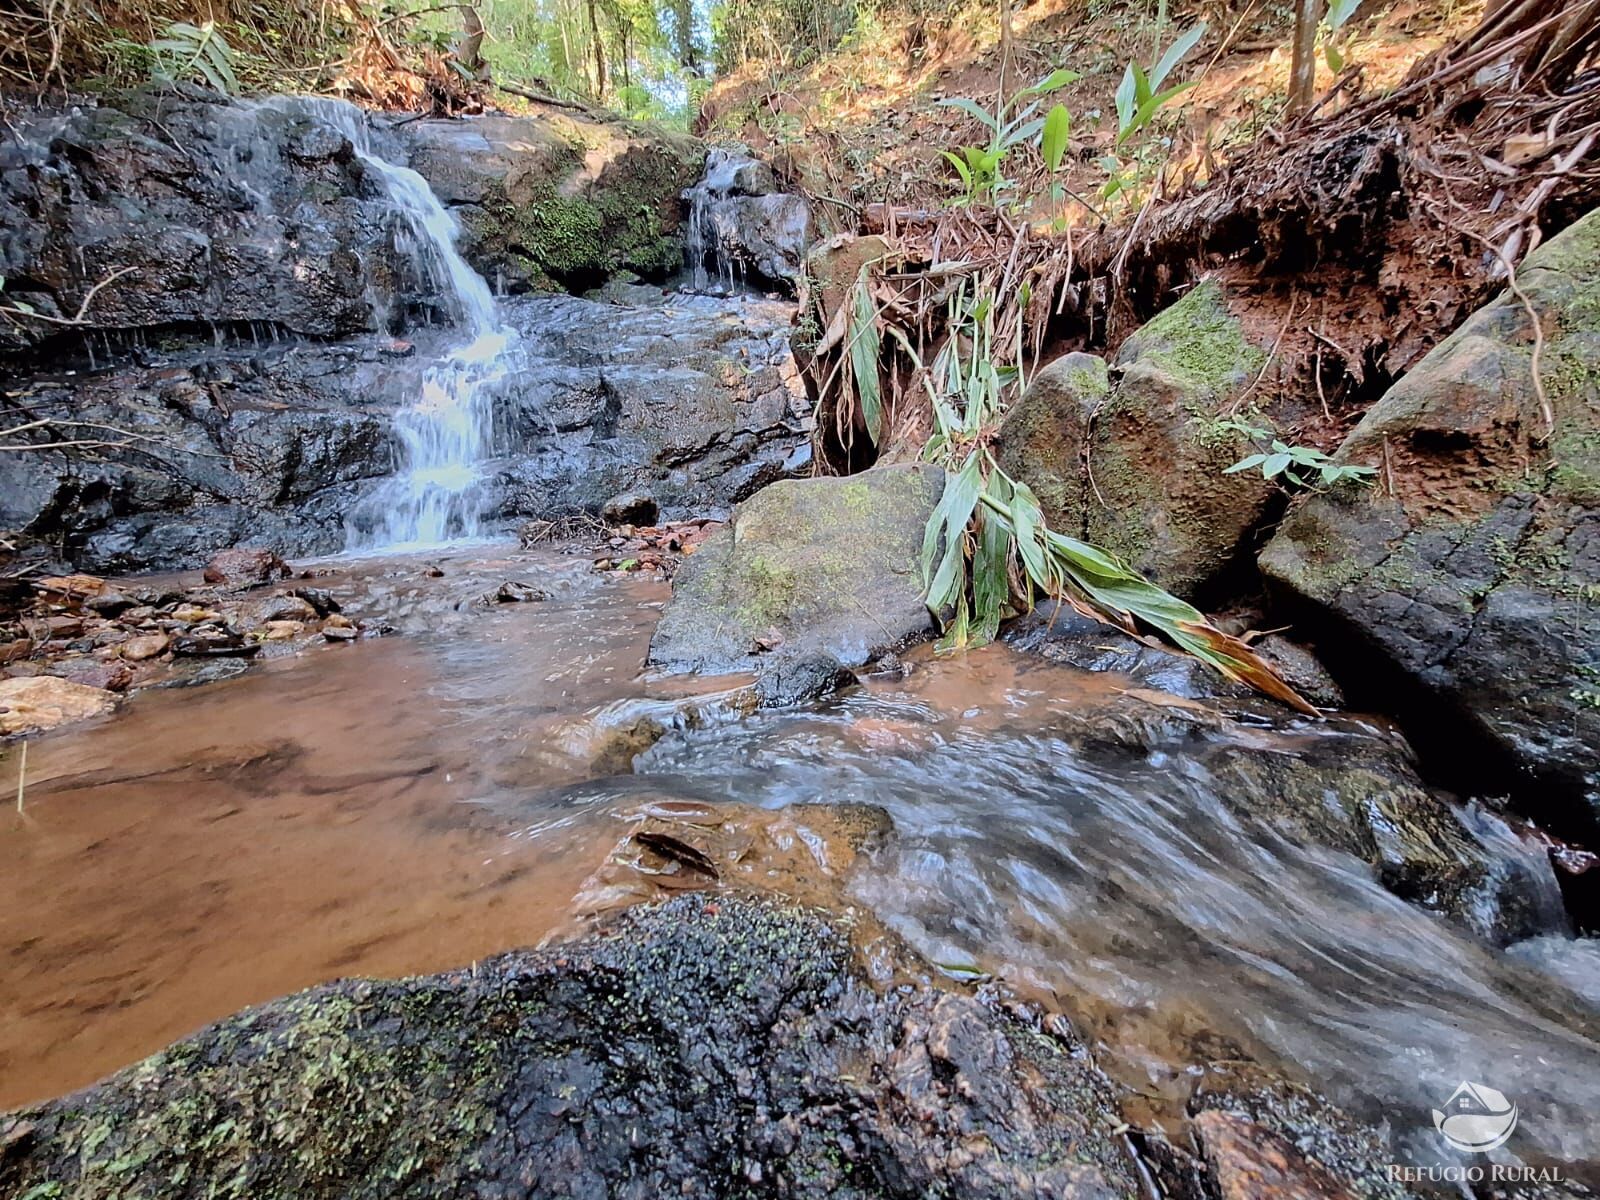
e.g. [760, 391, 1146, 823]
[0, 547, 1600, 1184]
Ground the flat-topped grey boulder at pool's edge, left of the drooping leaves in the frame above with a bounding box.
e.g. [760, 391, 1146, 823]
[650, 466, 944, 670]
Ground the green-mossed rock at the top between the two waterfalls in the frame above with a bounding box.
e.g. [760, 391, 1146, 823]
[410, 107, 706, 290]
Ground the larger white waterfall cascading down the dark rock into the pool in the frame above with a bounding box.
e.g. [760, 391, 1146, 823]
[251, 98, 515, 550]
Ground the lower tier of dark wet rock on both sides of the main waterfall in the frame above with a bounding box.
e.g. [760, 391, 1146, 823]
[0, 298, 806, 571]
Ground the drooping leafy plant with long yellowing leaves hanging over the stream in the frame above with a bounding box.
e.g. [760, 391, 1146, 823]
[902, 288, 1315, 712]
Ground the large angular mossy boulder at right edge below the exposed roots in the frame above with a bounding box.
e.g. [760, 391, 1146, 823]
[1261, 213, 1600, 818]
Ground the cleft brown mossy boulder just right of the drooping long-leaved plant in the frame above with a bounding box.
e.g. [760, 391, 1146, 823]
[1000, 280, 1272, 597]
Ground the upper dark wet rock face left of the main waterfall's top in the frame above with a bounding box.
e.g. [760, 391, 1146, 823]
[0, 93, 437, 354]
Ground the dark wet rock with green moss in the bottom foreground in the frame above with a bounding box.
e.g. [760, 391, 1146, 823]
[0, 893, 1141, 1200]
